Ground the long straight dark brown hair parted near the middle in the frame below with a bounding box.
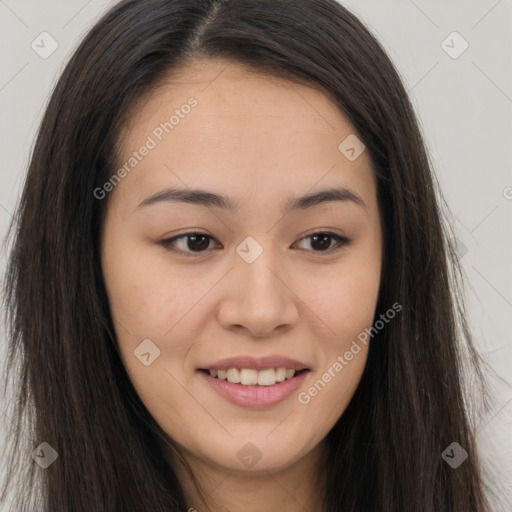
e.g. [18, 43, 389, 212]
[0, 0, 496, 512]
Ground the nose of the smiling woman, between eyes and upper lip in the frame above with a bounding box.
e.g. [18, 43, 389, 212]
[217, 246, 299, 338]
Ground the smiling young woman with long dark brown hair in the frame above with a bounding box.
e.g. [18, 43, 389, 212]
[0, 0, 496, 512]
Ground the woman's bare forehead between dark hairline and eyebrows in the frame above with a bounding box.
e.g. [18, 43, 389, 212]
[114, 60, 374, 214]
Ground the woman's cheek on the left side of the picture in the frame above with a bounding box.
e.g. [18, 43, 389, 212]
[105, 252, 201, 424]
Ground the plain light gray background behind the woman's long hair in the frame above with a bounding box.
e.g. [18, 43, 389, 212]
[0, 0, 512, 510]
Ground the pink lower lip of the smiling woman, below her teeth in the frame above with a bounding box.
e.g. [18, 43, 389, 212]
[199, 371, 309, 408]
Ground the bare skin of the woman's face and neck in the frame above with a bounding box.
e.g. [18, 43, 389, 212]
[102, 60, 382, 512]
